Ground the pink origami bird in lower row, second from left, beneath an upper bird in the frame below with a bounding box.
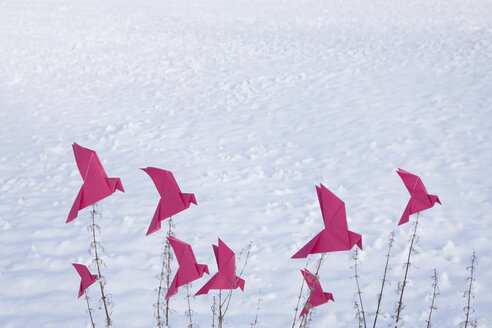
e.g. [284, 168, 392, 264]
[166, 237, 209, 299]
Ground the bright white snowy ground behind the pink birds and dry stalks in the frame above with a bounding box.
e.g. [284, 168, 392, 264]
[0, 0, 492, 327]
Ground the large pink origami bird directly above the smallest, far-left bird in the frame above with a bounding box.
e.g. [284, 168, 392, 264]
[67, 143, 125, 223]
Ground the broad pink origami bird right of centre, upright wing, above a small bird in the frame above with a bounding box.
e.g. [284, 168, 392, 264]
[292, 184, 362, 258]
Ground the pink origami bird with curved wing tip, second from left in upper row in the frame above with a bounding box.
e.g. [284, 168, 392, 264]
[141, 167, 197, 236]
